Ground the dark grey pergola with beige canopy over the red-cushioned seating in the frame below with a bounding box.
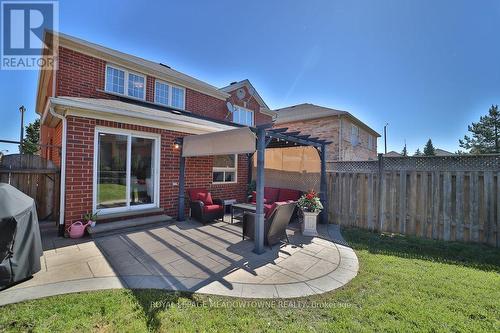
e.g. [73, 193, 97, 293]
[176, 124, 331, 254]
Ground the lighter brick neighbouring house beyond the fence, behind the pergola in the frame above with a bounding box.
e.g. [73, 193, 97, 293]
[274, 103, 380, 161]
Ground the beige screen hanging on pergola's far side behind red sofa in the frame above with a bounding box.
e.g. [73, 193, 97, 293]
[253, 146, 321, 191]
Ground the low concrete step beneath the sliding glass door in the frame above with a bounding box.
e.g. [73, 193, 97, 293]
[87, 214, 174, 238]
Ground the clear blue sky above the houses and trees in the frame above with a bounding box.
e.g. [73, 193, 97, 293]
[0, 0, 500, 152]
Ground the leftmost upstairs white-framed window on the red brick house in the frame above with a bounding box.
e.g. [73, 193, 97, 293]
[105, 65, 146, 99]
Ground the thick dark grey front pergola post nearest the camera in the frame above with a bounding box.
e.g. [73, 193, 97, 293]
[253, 128, 266, 254]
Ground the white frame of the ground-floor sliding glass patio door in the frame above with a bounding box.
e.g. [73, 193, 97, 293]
[92, 126, 161, 215]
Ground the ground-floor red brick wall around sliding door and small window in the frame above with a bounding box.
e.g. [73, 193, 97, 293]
[65, 116, 247, 225]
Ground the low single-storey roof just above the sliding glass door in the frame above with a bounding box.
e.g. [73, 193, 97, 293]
[42, 97, 241, 134]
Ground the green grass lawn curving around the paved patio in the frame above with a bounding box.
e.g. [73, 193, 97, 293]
[0, 229, 500, 332]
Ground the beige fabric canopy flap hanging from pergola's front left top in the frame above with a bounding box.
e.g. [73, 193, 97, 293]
[182, 127, 256, 157]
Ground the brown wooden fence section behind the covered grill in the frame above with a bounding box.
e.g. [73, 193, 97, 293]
[0, 154, 60, 220]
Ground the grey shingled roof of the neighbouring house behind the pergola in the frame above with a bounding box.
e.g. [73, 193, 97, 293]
[274, 103, 381, 137]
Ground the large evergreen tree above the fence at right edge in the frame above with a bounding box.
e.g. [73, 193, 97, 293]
[458, 105, 500, 154]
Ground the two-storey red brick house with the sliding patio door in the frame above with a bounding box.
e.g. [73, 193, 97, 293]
[36, 34, 274, 230]
